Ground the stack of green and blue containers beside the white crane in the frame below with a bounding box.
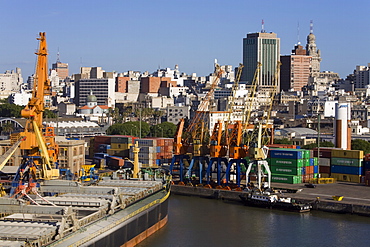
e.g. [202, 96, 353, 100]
[268, 149, 319, 183]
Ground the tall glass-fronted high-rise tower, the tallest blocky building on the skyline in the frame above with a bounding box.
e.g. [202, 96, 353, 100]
[242, 31, 280, 91]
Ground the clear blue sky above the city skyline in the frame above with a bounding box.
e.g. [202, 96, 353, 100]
[0, 0, 370, 80]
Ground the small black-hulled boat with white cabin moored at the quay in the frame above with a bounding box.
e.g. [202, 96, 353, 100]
[239, 192, 311, 213]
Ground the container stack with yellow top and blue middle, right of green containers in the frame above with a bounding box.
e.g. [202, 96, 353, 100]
[330, 149, 364, 183]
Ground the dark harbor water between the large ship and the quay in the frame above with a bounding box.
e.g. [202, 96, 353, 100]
[138, 194, 370, 247]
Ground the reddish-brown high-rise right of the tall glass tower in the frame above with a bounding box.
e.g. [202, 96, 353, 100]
[280, 44, 312, 91]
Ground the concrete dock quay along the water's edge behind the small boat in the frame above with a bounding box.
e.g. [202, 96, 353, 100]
[171, 182, 370, 216]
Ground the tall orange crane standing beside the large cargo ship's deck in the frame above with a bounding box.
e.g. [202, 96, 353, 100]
[12, 32, 59, 193]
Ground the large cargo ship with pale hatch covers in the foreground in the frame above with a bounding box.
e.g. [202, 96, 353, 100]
[0, 174, 170, 246]
